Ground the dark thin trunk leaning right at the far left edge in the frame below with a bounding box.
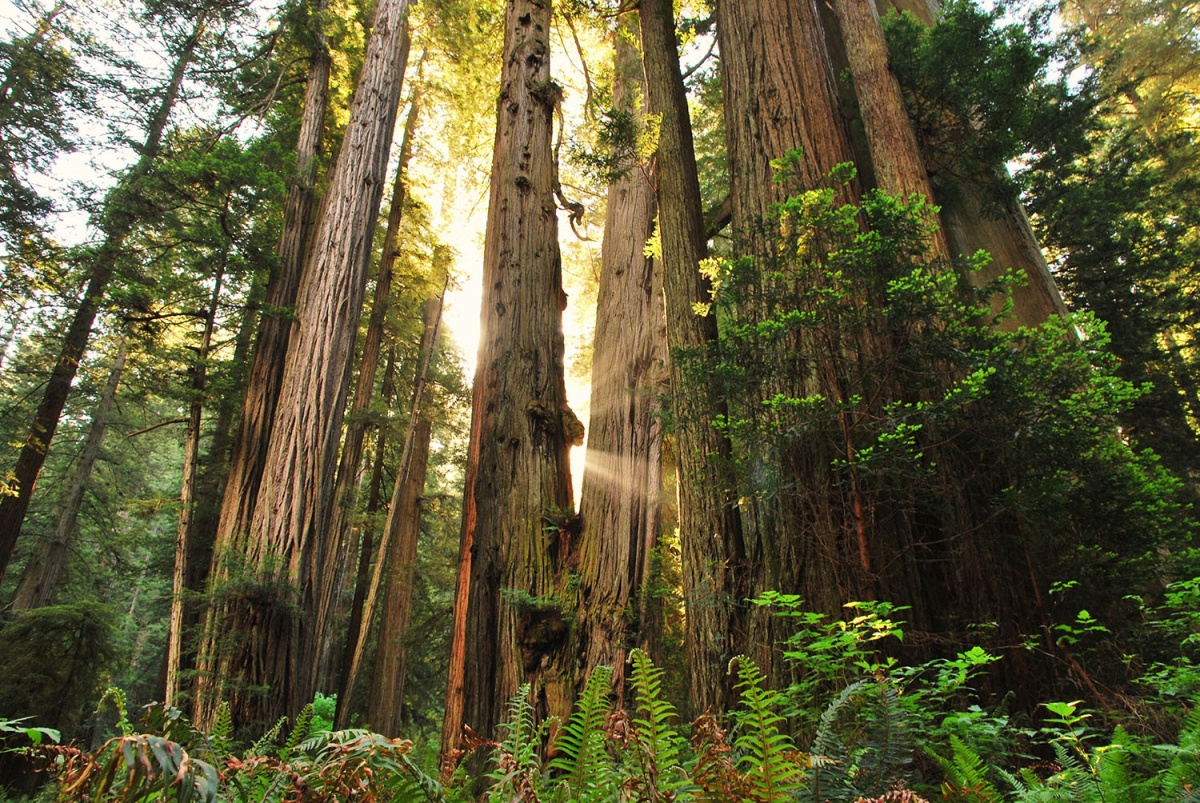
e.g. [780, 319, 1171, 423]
[0, 11, 208, 580]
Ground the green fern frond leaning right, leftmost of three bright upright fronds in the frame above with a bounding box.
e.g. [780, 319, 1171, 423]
[550, 666, 616, 803]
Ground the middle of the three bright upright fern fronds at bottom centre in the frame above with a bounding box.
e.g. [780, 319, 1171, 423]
[626, 649, 688, 801]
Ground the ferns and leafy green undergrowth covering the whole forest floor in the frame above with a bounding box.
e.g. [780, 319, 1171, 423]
[0, 581, 1200, 803]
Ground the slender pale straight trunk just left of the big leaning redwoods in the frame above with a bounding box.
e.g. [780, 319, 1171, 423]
[163, 260, 229, 706]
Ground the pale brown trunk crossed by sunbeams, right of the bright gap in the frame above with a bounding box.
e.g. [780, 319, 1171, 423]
[575, 12, 667, 689]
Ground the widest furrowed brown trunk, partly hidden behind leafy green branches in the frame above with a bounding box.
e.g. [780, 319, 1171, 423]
[716, 0, 871, 679]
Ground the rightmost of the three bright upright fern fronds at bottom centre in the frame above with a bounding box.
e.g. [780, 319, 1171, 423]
[733, 655, 803, 803]
